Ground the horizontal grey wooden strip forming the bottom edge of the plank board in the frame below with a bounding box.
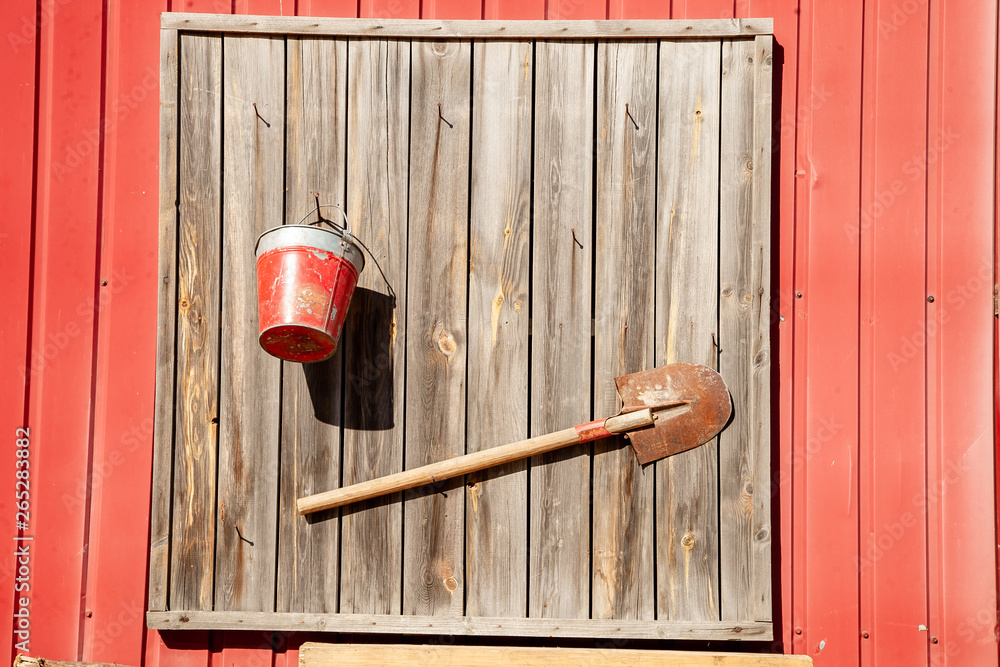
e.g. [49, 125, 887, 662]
[146, 611, 773, 641]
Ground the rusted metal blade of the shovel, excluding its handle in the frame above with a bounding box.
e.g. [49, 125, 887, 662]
[615, 363, 732, 465]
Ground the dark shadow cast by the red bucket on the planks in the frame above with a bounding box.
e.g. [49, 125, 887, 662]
[302, 287, 395, 431]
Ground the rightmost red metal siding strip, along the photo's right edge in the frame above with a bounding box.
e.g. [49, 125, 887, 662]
[927, 2, 997, 665]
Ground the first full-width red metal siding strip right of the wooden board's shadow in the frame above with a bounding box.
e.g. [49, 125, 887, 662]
[792, 3, 863, 665]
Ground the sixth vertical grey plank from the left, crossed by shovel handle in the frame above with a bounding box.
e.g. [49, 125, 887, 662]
[465, 41, 534, 617]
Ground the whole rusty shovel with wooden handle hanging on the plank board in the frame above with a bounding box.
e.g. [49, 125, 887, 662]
[298, 363, 732, 514]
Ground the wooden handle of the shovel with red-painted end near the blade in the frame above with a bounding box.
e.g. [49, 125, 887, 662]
[297, 409, 654, 514]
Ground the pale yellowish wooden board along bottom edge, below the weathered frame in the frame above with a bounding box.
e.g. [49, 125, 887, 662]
[299, 642, 813, 667]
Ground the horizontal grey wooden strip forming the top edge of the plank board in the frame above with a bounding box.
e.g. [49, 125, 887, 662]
[160, 12, 774, 39]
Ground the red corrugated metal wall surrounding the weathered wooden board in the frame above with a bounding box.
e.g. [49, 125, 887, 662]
[0, 0, 1000, 667]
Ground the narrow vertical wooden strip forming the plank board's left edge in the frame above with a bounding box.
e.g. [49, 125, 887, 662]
[147, 29, 178, 610]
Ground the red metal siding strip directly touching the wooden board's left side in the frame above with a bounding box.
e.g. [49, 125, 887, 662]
[83, 0, 166, 664]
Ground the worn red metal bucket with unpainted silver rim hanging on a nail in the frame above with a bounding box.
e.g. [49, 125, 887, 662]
[256, 225, 365, 362]
